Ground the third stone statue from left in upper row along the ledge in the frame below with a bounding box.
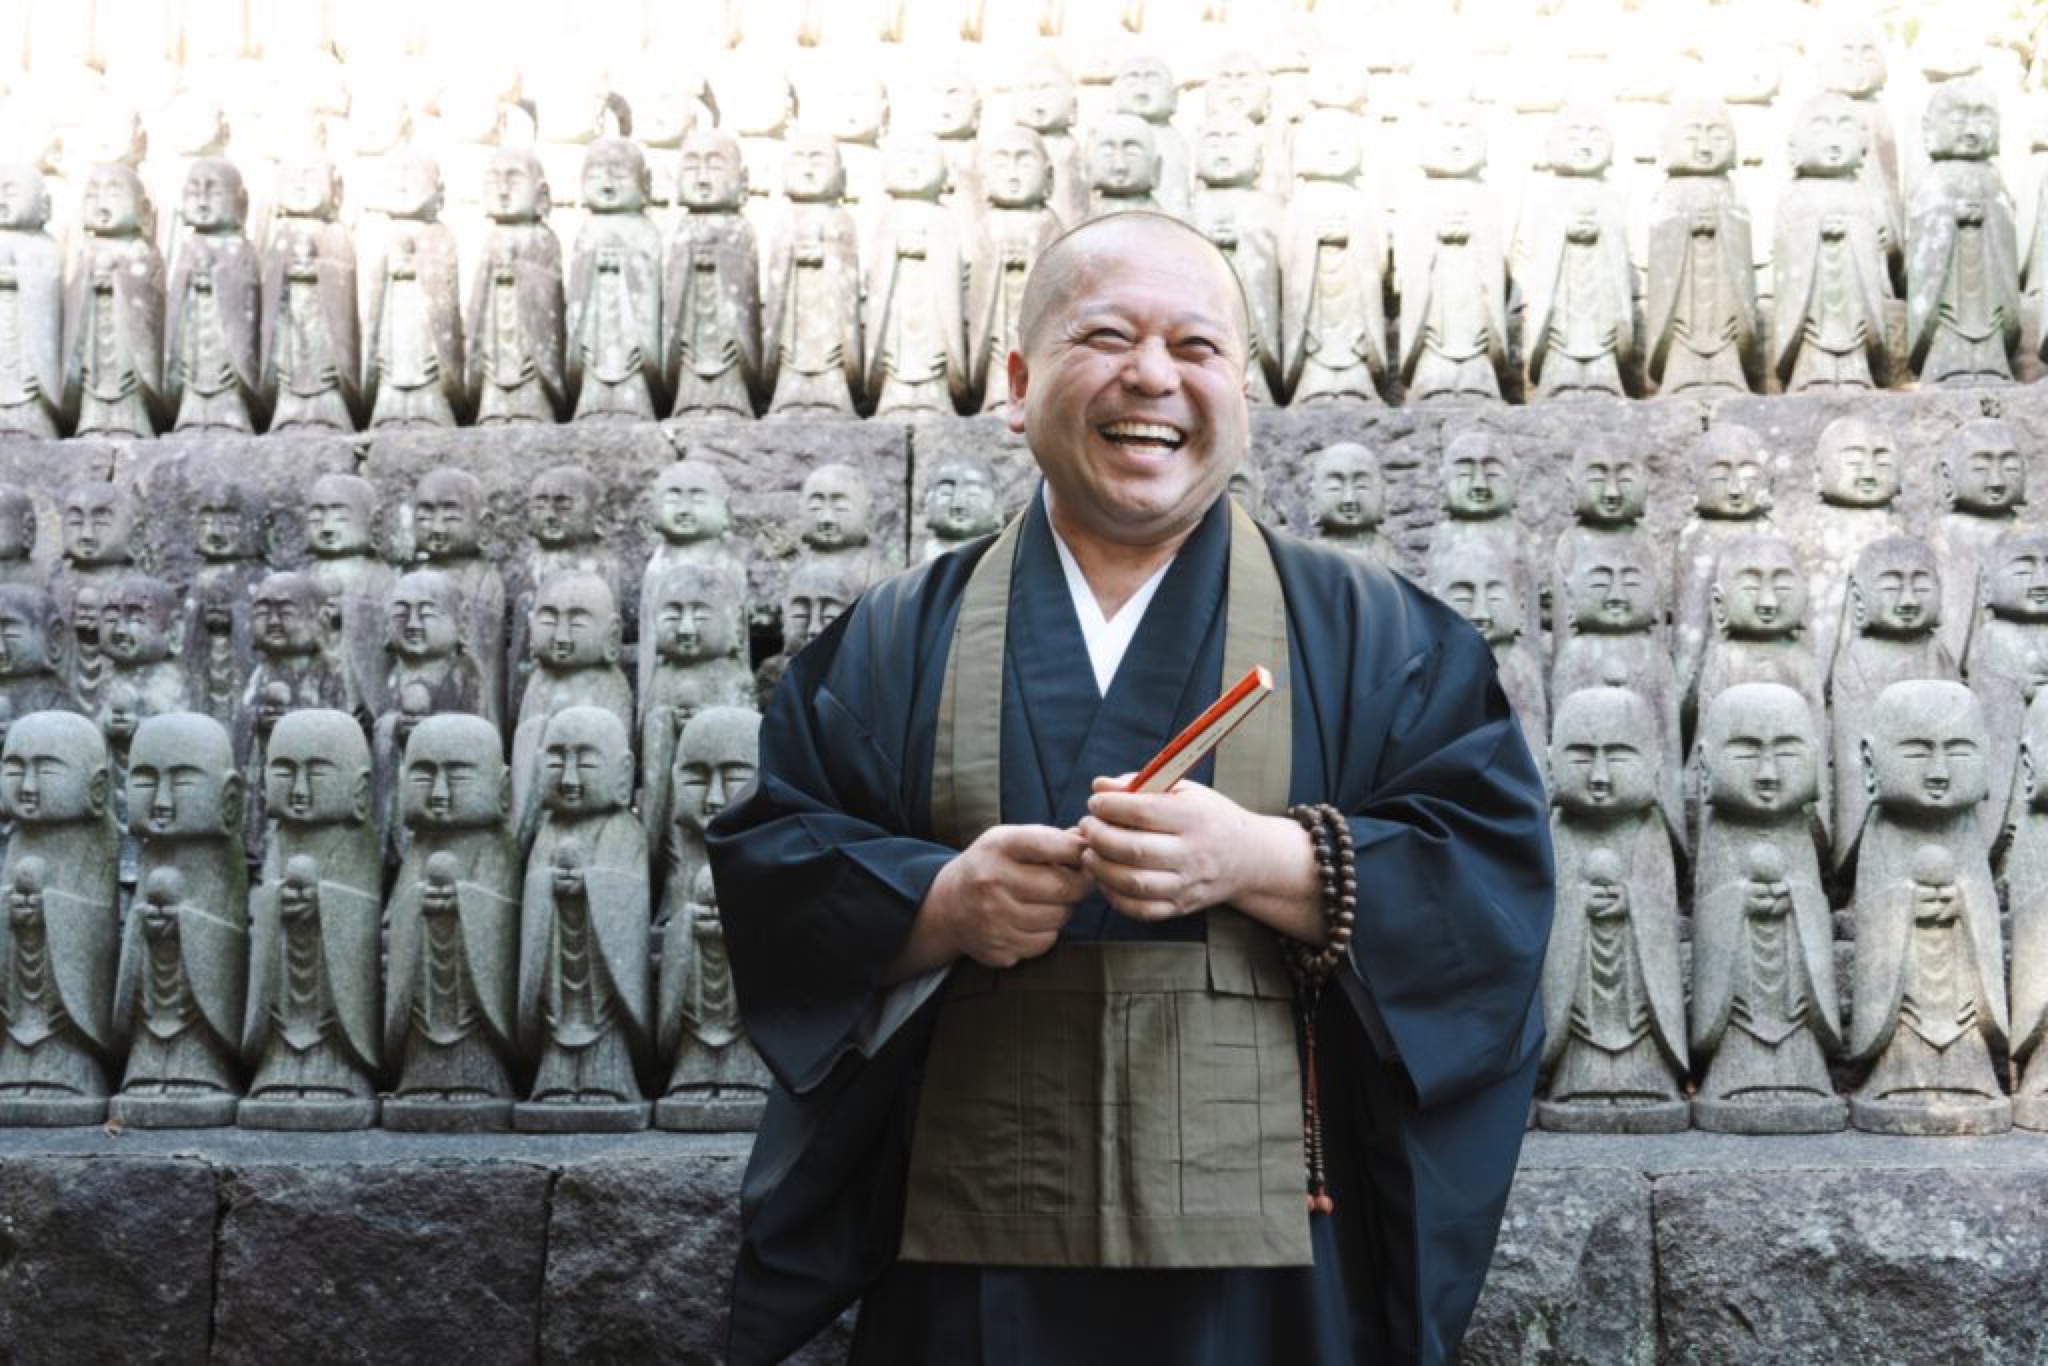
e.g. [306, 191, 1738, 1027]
[164, 156, 262, 432]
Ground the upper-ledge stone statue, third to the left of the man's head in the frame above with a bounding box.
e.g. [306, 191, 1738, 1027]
[762, 133, 864, 418]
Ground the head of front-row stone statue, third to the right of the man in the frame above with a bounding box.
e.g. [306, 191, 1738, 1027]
[1862, 678, 1991, 815]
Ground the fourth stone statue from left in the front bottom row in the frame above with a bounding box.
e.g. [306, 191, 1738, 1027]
[383, 715, 520, 1133]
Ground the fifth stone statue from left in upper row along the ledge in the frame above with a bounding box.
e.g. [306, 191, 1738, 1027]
[362, 150, 469, 428]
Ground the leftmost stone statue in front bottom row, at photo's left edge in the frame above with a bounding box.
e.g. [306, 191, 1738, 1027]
[0, 713, 121, 1126]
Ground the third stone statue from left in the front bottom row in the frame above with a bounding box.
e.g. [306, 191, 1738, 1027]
[236, 711, 383, 1128]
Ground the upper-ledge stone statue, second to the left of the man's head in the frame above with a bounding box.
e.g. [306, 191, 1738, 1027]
[860, 137, 967, 418]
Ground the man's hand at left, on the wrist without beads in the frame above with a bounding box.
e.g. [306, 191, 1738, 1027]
[891, 825, 1090, 981]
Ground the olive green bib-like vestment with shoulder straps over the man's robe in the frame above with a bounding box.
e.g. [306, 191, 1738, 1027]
[901, 504, 1313, 1268]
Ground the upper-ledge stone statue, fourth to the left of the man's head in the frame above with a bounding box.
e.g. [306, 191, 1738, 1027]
[662, 129, 764, 418]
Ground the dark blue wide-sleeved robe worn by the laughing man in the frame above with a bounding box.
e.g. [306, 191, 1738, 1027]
[709, 500, 1552, 1362]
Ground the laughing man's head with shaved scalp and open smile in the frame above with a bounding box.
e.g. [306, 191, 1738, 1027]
[1008, 217, 1251, 545]
